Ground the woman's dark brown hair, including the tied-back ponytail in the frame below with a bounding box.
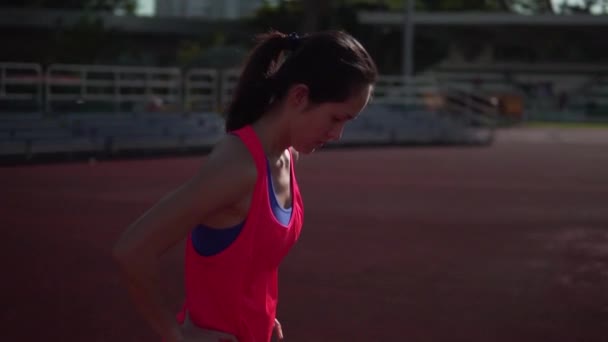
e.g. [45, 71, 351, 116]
[226, 31, 378, 131]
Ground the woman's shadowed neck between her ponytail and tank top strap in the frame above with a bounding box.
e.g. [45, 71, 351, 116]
[252, 110, 290, 162]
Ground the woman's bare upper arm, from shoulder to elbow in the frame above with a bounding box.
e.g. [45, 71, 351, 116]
[114, 137, 257, 258]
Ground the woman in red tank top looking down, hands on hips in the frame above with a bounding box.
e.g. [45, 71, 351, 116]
[114, 31, 377, 342]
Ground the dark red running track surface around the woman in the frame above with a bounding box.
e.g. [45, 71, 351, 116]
[0, 130, 608, 342]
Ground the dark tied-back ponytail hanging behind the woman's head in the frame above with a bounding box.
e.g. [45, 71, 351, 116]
[226, 31, 293, 131]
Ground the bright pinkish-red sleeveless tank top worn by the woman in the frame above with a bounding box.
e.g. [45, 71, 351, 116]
[178, 126, 303, 342]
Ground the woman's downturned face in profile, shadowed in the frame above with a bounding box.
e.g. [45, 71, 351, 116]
[292, 85, 372, 154]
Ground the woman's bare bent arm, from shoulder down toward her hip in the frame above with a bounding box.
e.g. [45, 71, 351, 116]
[113, 138, 257, 342]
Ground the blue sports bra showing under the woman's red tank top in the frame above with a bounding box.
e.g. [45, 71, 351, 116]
[191, 158, 293, 256]
